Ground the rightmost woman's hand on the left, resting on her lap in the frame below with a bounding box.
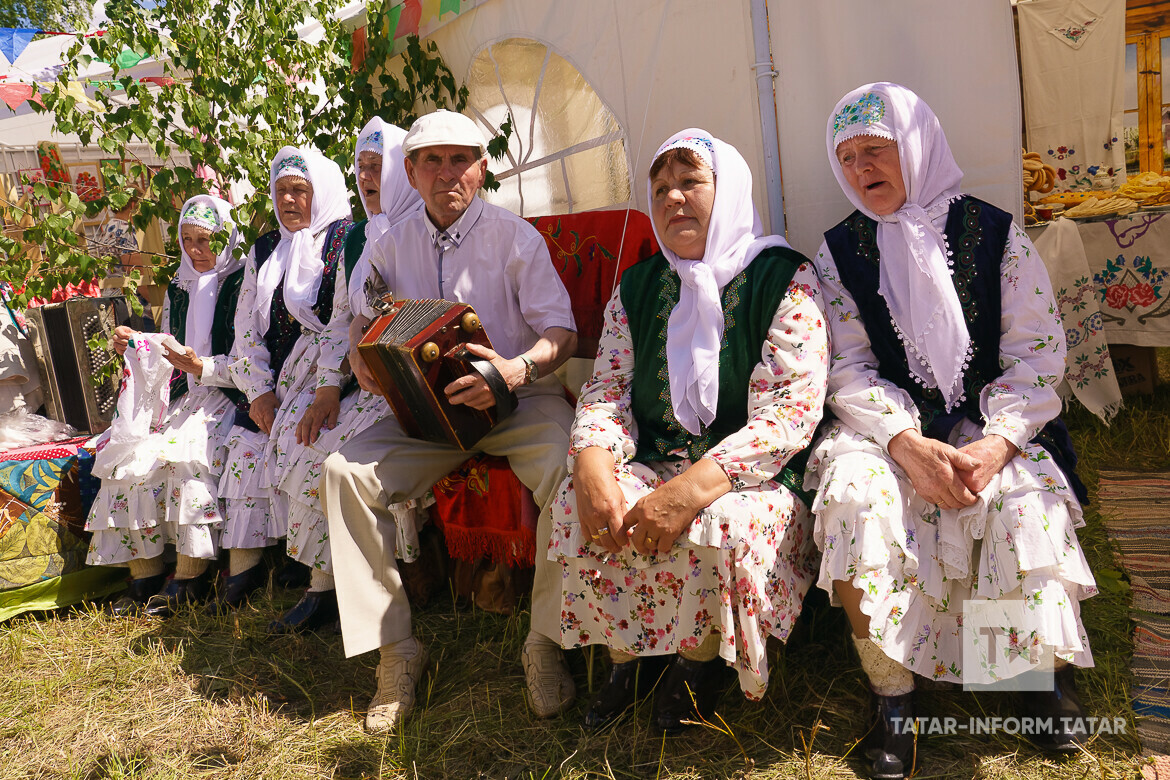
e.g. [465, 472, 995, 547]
[887, 428, 983, 509]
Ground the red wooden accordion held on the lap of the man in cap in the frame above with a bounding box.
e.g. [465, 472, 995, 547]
[358, 299, 516, 449]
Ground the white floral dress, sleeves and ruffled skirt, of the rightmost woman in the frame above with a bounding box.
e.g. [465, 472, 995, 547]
[805, 225, 1096, 682]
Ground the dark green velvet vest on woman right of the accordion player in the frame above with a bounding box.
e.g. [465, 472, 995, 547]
[620, 247, 806, 463]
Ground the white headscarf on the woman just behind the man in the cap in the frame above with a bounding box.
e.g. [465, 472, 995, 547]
[350, 117, 422, 301]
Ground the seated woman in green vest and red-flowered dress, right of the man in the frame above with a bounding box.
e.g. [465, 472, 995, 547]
[550, 129, 828, 732]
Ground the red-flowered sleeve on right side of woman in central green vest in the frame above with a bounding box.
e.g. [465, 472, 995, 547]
[703, 262, 828, 490]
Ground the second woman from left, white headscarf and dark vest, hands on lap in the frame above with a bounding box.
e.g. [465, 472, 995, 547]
[215, 146, 353, 631]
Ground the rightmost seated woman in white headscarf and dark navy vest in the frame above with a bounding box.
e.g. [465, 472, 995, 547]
[806, 83, 1095, 778]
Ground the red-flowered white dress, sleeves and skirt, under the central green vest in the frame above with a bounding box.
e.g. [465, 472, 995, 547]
[549, 263, 828, 699]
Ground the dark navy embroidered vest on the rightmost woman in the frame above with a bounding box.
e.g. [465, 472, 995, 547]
[825, 195, 1088, 504]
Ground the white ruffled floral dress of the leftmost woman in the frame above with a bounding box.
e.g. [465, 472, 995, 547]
[87, 281, 244, 564]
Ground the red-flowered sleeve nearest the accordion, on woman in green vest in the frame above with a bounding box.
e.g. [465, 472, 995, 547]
[569, 288, 638, 471]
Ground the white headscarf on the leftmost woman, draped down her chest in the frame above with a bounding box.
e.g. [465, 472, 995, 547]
[174, 195, 243, 357]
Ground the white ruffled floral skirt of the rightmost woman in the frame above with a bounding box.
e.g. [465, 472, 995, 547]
[805, 420, 1096, 683]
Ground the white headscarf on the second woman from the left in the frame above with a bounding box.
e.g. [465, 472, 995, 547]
[263, 146, 351, 333]
